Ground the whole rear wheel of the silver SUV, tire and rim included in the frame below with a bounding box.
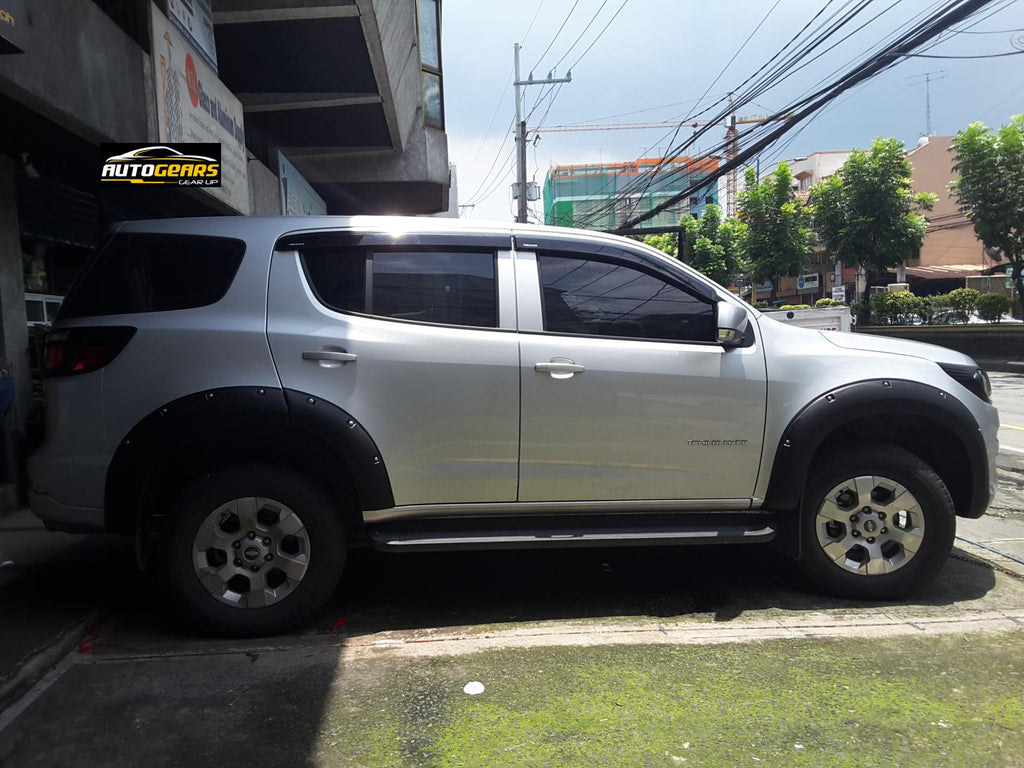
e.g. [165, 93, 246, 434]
[165, 466, 345, 635]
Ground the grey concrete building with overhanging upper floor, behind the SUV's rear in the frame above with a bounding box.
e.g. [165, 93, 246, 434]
[0, 0, 449, 505]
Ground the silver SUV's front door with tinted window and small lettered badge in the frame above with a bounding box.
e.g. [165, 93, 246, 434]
[515, 238, 766, 508]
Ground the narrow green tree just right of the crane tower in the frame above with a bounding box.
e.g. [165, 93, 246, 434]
[738, 163, 815, 294]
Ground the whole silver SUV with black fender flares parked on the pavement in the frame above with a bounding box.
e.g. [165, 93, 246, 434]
[30, 217, 998, 634]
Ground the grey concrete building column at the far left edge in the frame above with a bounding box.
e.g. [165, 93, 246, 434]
[0, 155, 32, 510]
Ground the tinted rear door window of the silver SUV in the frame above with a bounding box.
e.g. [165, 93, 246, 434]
[302, 248, 498, 328]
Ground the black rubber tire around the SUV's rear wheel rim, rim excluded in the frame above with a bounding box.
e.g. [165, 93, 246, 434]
[162, 466, 345, 637]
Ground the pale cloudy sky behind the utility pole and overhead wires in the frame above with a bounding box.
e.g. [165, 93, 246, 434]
[442, 0, 1024, 220]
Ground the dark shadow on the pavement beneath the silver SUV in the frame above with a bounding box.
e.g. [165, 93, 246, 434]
[317, 546, 995, 634]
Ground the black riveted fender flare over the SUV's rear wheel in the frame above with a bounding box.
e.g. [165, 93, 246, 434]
[104, 386, 394, 534]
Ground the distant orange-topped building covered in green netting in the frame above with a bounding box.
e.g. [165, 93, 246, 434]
[544, 157, 719, 230]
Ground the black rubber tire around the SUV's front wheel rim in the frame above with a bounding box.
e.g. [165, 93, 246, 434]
[800, 444, 956, 600]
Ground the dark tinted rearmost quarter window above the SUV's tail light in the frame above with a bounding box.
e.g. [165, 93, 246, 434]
[60, 232, 246, 319]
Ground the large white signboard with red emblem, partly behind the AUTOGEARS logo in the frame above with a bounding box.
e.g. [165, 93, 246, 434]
[150, 6, 249, 214]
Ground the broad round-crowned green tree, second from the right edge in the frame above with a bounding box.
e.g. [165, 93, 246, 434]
[811, 137, 937, 280]
